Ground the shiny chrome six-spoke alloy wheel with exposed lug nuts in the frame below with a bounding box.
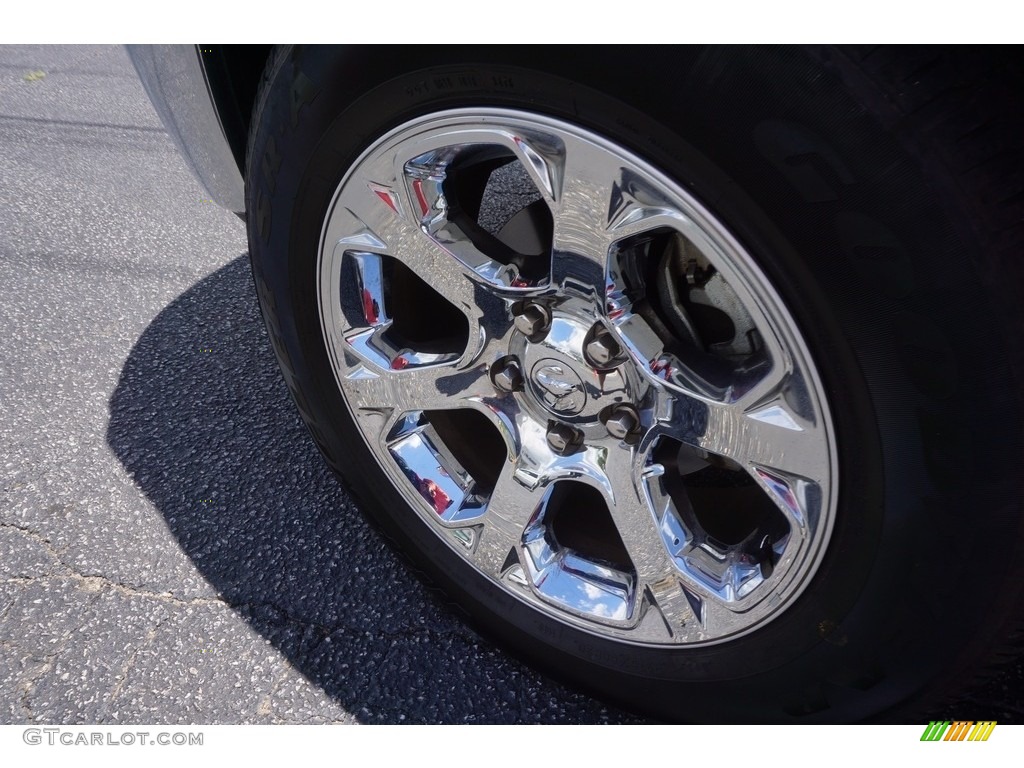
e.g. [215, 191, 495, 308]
[317, 109, 838, 646]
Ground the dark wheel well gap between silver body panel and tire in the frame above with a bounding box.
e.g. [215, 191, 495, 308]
[200, 45, 273, 173]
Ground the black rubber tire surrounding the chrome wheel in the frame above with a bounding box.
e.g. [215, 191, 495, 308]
[246, 47, 1024, 722]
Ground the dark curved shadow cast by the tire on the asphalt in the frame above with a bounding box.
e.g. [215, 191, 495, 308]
[108, 255, 630, 723]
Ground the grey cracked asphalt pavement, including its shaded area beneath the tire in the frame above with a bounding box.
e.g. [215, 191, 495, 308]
[0, 46, 1024, 724]
